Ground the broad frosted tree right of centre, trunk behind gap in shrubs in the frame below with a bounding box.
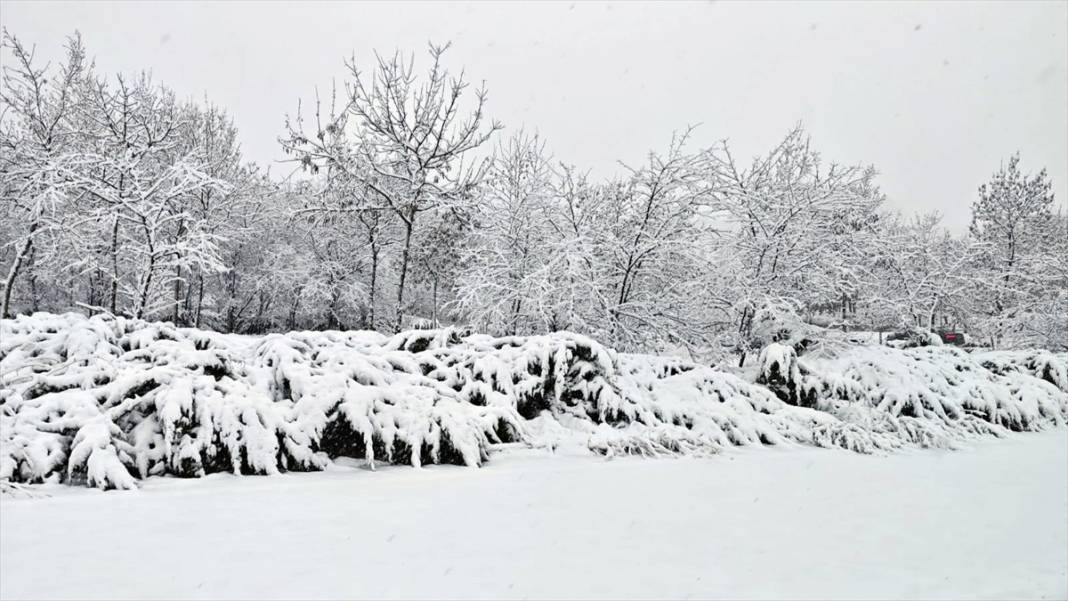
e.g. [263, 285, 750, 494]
[710, 127, 883, 363]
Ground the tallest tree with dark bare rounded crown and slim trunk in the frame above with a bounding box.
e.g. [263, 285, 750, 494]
[283, 45, 501, 329]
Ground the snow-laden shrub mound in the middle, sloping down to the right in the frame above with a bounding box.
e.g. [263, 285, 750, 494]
[387, 331, 870, 456]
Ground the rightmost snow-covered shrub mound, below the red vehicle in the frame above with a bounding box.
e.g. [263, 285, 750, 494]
[803, 346, 1068, 446]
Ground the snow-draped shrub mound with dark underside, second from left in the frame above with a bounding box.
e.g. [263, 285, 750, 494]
[251, 331, 518, 469]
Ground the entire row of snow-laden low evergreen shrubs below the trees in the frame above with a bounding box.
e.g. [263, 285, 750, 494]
[0, 314, 1068, 489]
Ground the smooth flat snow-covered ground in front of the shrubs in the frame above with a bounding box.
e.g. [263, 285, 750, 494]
[0, 427, 1068, 599]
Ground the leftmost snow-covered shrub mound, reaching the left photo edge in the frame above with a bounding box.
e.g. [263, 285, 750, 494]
[0, 314, 309, 488]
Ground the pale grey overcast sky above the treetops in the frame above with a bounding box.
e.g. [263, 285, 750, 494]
[0, 1, 1068, 228]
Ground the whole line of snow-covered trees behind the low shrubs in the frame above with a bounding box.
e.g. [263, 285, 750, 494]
[0, 31, 1068, 362]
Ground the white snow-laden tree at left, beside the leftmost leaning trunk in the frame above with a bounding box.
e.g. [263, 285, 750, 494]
[65, 75, 229, 317]
